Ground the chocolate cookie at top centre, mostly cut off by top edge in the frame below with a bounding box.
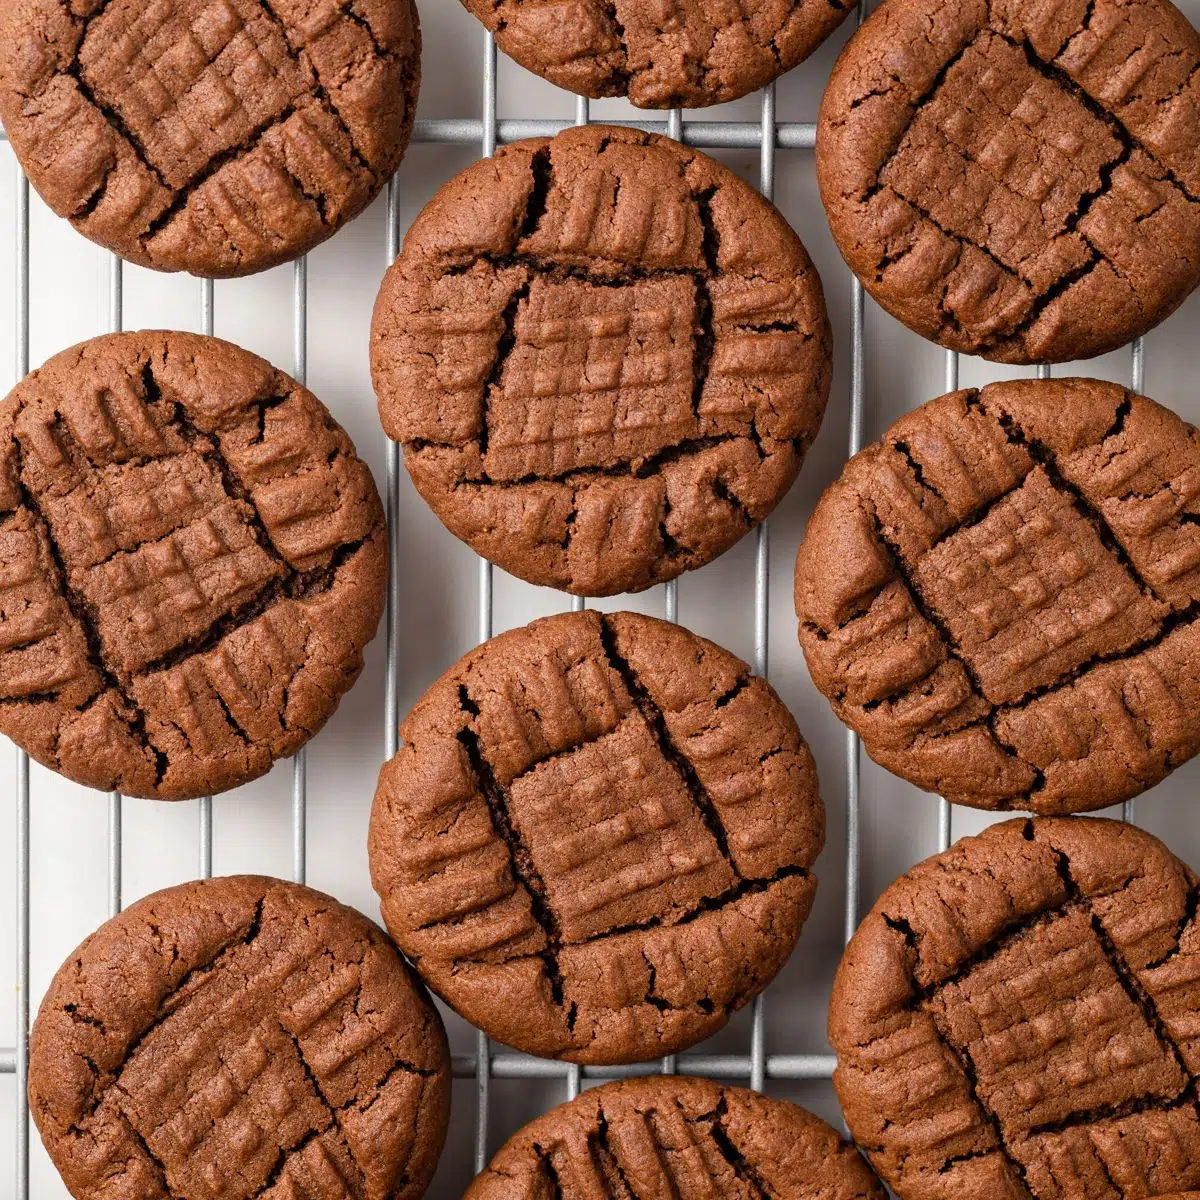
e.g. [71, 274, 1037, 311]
[453, 0, 854, 108]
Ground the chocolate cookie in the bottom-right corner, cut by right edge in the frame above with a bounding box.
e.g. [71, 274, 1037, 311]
[829, 817, 1200, 1200]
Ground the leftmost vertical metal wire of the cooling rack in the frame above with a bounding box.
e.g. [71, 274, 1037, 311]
[13, 157, 30, 1200]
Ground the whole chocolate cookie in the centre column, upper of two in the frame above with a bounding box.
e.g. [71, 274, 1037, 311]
[371, 126, 830, 595]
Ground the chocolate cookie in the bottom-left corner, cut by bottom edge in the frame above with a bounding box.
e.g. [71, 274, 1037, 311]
[29, 875, 450, 1200]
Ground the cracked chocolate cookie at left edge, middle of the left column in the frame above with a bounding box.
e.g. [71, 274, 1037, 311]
[0, 332, 388, 800]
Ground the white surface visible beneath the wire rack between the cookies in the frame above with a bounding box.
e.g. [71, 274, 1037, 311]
[0, 0, 1200, 1200]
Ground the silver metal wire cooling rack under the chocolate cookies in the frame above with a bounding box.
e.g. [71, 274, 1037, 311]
[0, 7, 1145, 1200]
